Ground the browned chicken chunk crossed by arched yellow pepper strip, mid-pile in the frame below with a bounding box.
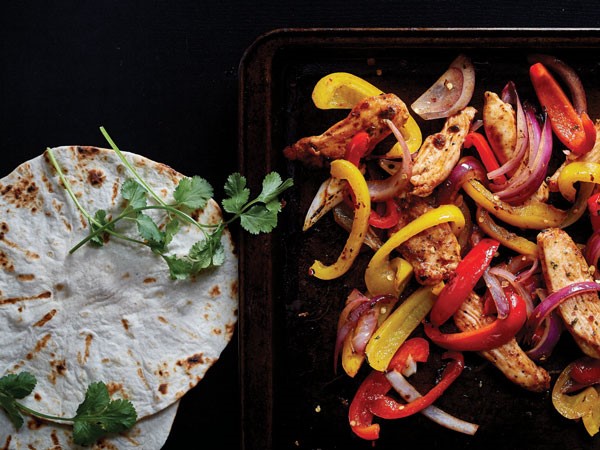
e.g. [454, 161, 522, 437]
[397, 197, 460, 285]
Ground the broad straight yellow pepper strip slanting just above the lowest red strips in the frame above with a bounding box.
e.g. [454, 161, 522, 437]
[365, 286, 439, 371]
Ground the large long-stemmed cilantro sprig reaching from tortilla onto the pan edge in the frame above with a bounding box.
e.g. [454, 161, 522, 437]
[47, 127, 293, 279]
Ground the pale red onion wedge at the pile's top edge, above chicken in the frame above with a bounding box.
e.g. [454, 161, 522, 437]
[411, 55, 475, 120]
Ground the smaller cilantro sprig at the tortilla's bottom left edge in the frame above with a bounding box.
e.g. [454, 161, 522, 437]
[0, 372, 137, 445]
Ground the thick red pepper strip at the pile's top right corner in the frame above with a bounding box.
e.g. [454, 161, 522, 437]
[529, 63, 596, 155]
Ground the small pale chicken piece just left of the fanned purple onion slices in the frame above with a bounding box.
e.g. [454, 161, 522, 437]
[483, 91, 517, 164]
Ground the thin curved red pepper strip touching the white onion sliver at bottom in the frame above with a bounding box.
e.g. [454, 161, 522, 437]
[370, 352, 465, 419]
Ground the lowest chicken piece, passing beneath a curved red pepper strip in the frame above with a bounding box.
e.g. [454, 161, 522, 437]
[454, 292, 550, 392]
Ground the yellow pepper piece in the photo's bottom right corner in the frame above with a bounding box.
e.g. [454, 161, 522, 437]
[552, 363, 600, 436]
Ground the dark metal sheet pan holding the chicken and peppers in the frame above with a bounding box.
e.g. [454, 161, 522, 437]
[239, 29, 600, 450]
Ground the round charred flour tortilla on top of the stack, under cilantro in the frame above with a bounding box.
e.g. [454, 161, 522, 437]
[0, 146, 238, 448]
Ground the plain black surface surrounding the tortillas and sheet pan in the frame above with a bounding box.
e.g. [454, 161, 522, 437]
[0, 0, 600, 449]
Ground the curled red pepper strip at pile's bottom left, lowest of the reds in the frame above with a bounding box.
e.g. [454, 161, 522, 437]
[348, 338, 429, 441]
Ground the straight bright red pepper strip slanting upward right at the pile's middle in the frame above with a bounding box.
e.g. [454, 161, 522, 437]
[429, 238, 500, 327]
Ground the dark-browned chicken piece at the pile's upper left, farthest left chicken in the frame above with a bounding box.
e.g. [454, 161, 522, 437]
[283, 94, 408, 167]
